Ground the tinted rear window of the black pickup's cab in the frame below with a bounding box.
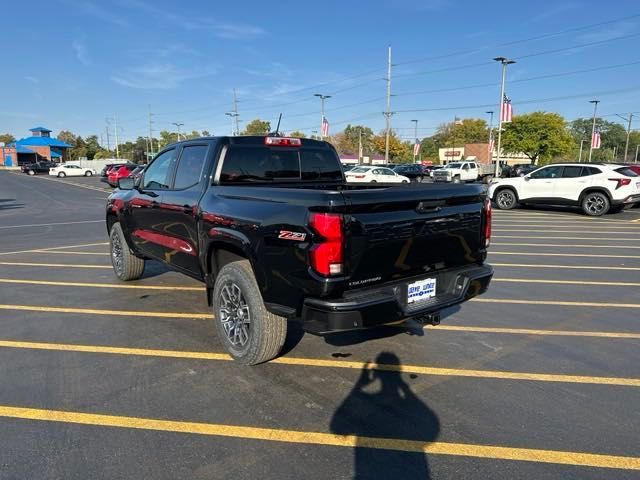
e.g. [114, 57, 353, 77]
[220, 145, 342, 183]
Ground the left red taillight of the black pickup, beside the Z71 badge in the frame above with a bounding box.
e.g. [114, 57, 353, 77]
[309, 213, 342, 277]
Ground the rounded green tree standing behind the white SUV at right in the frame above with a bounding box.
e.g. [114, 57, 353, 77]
[502, 112, 574, 165]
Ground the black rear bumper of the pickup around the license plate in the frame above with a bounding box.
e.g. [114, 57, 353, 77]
[302, 265, 493, 334]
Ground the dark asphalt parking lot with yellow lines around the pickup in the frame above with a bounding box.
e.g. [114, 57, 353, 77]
[0, 172, 640, 479]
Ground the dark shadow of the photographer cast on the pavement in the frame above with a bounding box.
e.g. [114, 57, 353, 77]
[330, 352, 440, 480]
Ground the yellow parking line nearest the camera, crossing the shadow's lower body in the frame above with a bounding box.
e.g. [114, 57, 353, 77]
[0, 406, 640, 470]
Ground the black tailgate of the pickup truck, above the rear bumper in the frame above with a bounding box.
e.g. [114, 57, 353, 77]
[342, 184, 486, 288]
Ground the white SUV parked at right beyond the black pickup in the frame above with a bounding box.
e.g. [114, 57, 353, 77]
[489, 163, 640, 216]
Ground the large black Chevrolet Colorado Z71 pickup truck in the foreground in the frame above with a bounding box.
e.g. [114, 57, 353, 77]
[106, 136, 493, 364]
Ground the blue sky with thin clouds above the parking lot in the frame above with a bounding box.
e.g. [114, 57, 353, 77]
[0, 0, 640, 139]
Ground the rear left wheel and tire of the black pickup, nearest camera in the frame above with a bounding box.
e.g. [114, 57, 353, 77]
[213, 260, 287, 365]
